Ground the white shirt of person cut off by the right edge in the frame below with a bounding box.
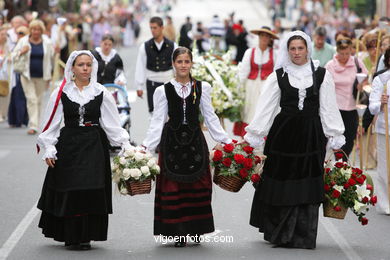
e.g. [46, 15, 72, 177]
[369, 70, 390, 134]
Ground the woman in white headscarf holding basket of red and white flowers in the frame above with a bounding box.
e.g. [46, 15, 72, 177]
[244, 31, 345, 248]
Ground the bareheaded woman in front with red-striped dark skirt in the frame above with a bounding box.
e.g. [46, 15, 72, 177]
[142, 47, 232, 247]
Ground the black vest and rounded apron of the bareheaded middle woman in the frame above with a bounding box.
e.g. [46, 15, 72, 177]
[160, 82, 209, 183]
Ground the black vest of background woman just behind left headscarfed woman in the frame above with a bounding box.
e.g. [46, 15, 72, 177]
[91, 50, 123, 84]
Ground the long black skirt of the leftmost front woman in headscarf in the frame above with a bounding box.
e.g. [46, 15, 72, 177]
[38, 127, 112, 244]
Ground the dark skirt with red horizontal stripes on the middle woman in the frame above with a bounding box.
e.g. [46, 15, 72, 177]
[153, 153, 214, 236]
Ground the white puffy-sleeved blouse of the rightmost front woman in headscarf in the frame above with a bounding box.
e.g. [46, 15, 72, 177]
[244, 64, 345, 149]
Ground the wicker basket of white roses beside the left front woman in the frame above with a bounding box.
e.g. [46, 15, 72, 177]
[112, 148, 160, 196]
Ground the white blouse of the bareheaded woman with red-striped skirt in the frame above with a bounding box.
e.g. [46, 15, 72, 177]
[142, 79, 232, 151]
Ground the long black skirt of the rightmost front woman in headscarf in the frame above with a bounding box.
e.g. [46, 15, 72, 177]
[250, 113, 326, 248]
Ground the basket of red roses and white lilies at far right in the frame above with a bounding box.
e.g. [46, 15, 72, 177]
[324, 153, 377, 225]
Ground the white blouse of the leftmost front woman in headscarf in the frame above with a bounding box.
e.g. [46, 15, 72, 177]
[37, 82, 130, 160]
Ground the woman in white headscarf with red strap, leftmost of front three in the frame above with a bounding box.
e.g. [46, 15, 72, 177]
[37, 51, 130, 249]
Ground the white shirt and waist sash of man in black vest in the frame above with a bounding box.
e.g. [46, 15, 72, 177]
[134, 41, 177, 90]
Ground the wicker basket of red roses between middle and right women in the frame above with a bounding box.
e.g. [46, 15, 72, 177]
[210, 140, 266, 192]
